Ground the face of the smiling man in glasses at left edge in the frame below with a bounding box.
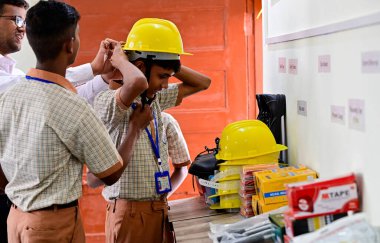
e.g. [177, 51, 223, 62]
[0, 4, 26, 55]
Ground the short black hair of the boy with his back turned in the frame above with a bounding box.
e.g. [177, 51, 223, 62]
[26, 1, 80, 62]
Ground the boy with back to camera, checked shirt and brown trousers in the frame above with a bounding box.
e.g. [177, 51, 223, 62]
[0, 1, 152, 243]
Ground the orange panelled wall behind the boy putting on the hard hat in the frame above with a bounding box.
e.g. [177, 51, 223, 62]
[66, 0, 262, 242]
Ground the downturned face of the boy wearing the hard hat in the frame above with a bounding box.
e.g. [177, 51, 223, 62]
[147, 65, 174, 98]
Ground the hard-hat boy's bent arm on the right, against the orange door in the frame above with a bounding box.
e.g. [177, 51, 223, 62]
[174, 65, 211, 105]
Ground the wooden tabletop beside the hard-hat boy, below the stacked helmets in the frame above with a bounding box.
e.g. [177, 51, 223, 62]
[169, 196, 242, 243]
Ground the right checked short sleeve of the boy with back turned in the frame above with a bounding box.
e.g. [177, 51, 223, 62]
[68, 105, 123, 178]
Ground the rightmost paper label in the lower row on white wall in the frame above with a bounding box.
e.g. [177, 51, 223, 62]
[348, 99, 365, 131]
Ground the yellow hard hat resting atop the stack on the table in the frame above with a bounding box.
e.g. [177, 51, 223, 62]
[216, 120, 287, 160]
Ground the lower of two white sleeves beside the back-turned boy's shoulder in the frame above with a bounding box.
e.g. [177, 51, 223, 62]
[76, 75, 108, 105]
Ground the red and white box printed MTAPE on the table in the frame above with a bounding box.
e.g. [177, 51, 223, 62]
[287, 173, 360, 219]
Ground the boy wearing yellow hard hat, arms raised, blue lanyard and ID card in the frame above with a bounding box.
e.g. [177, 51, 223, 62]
[90, 18, 211, 242]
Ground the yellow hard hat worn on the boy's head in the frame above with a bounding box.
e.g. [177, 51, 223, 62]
[123, 18, 191, 60]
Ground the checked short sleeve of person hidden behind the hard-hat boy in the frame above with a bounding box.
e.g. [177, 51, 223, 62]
[162, 112, 190, 168]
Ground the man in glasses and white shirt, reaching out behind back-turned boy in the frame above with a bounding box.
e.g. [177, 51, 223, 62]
[0, 0, 114, 243]
